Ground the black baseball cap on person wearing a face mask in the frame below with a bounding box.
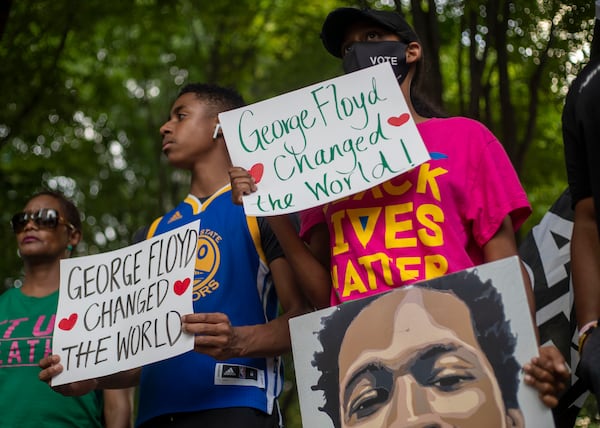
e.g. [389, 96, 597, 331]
[321, 7, 419, 58]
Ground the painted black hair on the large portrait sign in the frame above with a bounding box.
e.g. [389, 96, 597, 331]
[312, 270, 521, 427]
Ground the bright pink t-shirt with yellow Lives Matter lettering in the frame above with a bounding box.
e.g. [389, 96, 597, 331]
[300, 117, 531, 305]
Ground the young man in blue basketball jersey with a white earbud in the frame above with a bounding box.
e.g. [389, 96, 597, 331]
[40, 84, 307, 428]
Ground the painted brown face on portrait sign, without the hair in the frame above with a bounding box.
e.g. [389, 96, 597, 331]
[339, 288, 522, 428]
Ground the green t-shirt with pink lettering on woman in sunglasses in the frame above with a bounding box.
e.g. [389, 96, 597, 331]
[0, 288, 102, 428]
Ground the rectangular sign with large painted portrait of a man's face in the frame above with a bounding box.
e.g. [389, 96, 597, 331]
[290, 257, 554, 428]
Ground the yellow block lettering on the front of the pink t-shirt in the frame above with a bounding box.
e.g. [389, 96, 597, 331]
[328, 163, 448, 298]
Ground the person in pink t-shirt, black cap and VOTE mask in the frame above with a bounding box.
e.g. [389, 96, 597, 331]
[230, 8, 568, 406]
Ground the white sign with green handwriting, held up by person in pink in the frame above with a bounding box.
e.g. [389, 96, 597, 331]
[219, 63, 429, 216]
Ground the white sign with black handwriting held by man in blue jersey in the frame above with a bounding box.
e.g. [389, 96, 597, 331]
[52, 221, 200, 385]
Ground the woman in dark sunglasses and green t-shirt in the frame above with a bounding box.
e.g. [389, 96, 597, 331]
[0, 191, 132, 428]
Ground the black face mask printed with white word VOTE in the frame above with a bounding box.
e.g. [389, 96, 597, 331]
[343, 41, 409, 83]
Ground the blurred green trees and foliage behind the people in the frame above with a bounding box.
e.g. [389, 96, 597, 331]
[0, 0, 594, 427]
